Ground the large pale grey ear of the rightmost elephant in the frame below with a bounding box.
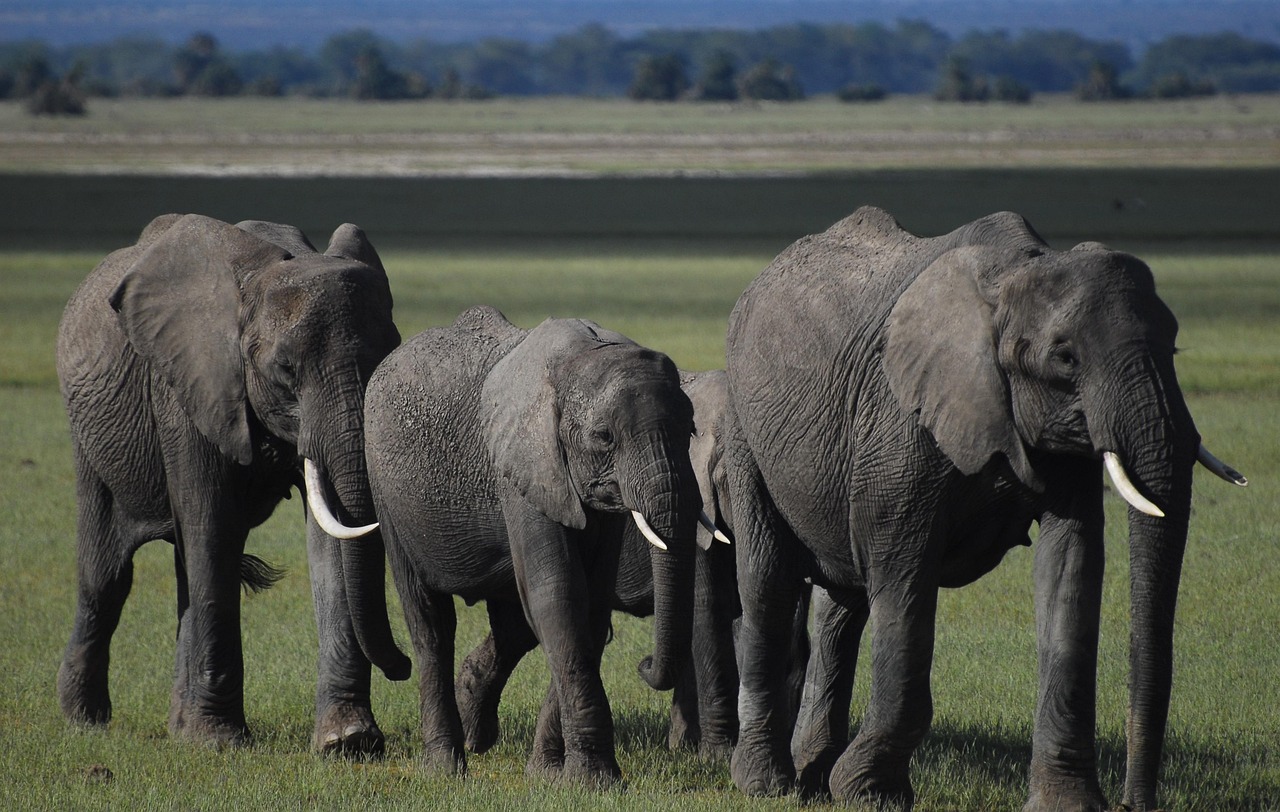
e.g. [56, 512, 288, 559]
[883, 247, 1043, 491]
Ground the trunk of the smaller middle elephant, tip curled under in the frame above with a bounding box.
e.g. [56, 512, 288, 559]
[622, 427, 701, 690]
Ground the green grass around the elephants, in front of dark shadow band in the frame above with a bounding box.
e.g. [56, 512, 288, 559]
[0, 236, 1280, 812]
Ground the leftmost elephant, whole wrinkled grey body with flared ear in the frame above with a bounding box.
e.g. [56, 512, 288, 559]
[58, 215, 408, 752]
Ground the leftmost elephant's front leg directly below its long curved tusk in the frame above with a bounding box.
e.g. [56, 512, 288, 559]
[307, 517, 387, 756]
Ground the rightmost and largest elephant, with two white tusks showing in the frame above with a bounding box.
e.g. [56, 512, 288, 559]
[726, 206, 1245, 811]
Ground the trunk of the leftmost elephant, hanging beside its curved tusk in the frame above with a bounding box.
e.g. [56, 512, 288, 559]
[298, 398, 411, 680]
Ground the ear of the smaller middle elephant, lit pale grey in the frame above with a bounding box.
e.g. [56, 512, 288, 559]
[481, 320, 604, 530]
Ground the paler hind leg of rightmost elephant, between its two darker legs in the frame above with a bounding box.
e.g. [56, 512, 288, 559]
[791, 587, 870, 797]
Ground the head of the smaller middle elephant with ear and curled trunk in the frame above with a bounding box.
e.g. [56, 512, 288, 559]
[483, 320, 700, 689]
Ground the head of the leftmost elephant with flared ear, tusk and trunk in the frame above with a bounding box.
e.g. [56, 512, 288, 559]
[110, 215, 408, 672]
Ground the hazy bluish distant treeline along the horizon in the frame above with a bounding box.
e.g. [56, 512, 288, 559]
[0, 20, 1280, 113]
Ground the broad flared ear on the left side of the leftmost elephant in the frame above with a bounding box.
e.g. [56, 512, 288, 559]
[109, 214, 288, 465]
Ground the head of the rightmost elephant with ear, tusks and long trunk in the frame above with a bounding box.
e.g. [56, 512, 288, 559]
[883, 214, 1244, 808]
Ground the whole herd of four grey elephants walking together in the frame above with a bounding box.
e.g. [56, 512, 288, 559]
[58, 207, 1245, 809]
